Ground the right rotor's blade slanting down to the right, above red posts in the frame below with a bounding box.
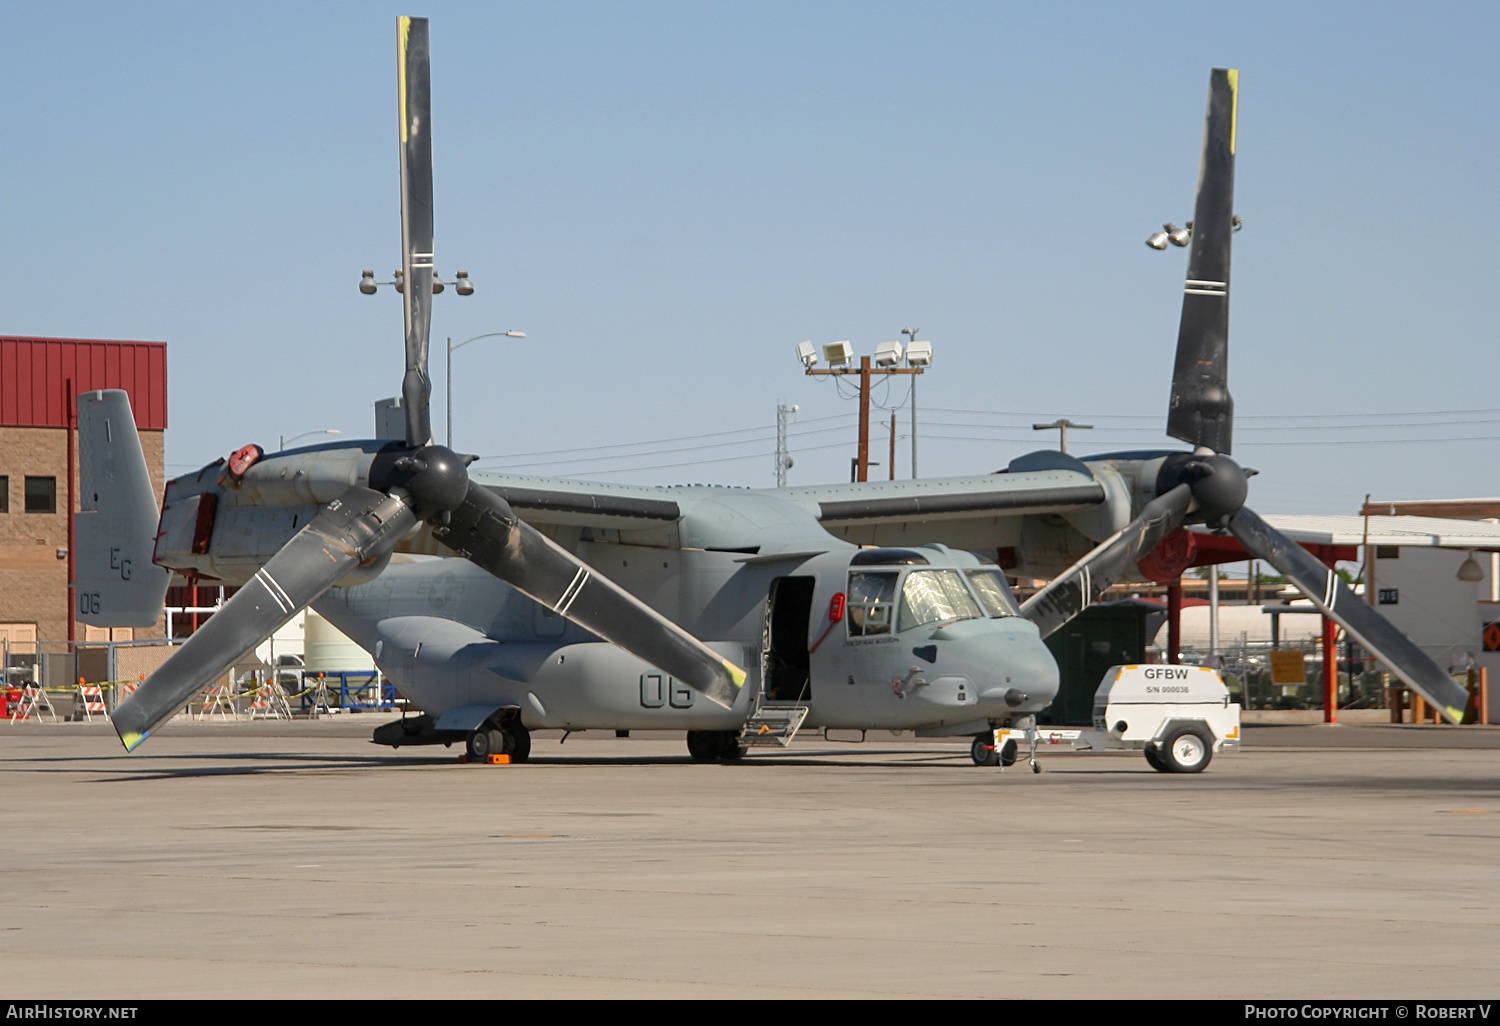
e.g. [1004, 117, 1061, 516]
[1229, 507, 1469, 723]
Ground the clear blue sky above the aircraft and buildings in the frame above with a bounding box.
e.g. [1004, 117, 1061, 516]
[0, 0, 1500, 513]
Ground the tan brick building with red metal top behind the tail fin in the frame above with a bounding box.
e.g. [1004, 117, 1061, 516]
[0, 338, 167, 651]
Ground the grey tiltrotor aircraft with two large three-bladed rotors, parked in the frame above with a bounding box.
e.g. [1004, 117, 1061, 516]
[77, 18, 1466, 761]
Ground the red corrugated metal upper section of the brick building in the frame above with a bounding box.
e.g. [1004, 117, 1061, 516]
[0, 338, 167, 431]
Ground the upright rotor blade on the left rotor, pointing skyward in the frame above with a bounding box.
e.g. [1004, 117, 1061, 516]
[396, 18, 432, 449]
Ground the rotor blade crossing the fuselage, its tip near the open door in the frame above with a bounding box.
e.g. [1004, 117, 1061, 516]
[440, 482, 746, 708]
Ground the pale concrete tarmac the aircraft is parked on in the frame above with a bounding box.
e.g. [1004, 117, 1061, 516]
[0, 717, 1500, 1001]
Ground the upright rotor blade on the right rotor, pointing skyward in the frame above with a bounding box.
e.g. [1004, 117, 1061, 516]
[1167, 68, 1239, 453]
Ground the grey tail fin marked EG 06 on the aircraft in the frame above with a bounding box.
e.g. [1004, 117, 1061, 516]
[74, 389, 171, 627]
